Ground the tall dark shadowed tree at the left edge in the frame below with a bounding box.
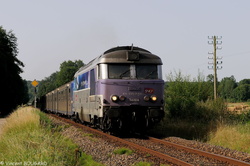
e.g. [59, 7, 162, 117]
[0, 26, 28, 114]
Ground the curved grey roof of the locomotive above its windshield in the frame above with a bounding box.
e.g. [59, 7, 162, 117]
[76, 46, 162, 74]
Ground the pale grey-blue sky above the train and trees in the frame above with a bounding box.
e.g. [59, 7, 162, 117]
[0, 0, 250, 82]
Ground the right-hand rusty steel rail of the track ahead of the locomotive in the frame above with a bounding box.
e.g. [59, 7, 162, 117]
[148, 137, 250, 166]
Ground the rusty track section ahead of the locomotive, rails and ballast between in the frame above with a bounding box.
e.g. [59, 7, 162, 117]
[128, 137, 250, 166]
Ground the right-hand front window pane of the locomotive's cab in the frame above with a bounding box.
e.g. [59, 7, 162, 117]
[136, 65, 158, 79]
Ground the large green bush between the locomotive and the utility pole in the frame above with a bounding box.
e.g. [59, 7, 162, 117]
[165, 72, 220, 121]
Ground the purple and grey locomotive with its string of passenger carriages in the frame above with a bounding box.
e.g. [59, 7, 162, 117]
[45, 45, 164, 132]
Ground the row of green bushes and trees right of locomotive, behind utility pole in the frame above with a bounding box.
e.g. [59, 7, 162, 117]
[165, 71, 250, 122]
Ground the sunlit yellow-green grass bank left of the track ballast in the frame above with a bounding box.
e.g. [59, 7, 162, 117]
[0, 107, 101, 166]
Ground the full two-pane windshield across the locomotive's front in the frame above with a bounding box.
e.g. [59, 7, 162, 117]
[108, 64, 159, 79]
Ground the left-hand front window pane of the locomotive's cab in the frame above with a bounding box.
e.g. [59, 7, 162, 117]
[108, 64, 131, 79]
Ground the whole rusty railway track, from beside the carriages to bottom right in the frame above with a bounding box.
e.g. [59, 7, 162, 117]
[47, 114, 250, 166]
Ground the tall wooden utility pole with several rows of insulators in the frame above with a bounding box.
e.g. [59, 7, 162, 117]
[208, 36, 222, 100]
